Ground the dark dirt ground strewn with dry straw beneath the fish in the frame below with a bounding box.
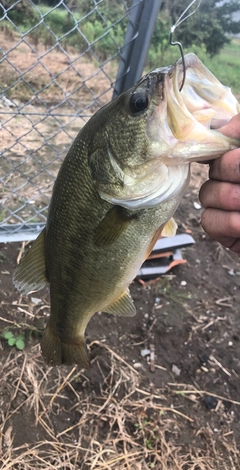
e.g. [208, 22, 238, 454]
[0, 30, 240, 470]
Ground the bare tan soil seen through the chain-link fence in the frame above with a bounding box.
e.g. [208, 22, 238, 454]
[0, 31, 117, 223]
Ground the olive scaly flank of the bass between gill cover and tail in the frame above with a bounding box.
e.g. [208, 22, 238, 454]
[46, 120, 183, 348]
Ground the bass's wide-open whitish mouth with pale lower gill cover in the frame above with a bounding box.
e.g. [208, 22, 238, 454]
[98, 54, 240, 210]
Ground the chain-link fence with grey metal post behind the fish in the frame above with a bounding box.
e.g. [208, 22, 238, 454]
[0, 0, 161, 242]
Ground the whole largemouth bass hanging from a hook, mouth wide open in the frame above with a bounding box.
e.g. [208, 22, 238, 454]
[14, 54, 240, 368]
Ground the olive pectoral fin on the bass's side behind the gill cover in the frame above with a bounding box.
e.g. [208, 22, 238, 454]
[94, 206, 137, 246]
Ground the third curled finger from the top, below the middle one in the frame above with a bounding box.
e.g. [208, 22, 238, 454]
[201, 208, 240, 242]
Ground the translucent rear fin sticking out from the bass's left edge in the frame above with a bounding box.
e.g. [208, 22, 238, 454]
[13, 229, 47, 294]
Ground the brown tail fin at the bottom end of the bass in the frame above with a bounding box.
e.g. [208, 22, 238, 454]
[41, 323, 90, 369]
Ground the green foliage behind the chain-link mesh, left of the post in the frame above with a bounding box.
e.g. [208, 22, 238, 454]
[4, 0, 127, 60]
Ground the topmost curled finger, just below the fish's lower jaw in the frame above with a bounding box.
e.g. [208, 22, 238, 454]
[209, 148, 240, 183]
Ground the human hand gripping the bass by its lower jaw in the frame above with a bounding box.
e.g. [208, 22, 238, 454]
[199, 114, 240, 257]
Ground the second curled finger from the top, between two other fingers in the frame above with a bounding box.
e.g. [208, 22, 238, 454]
[199, 180, 240, 210]
